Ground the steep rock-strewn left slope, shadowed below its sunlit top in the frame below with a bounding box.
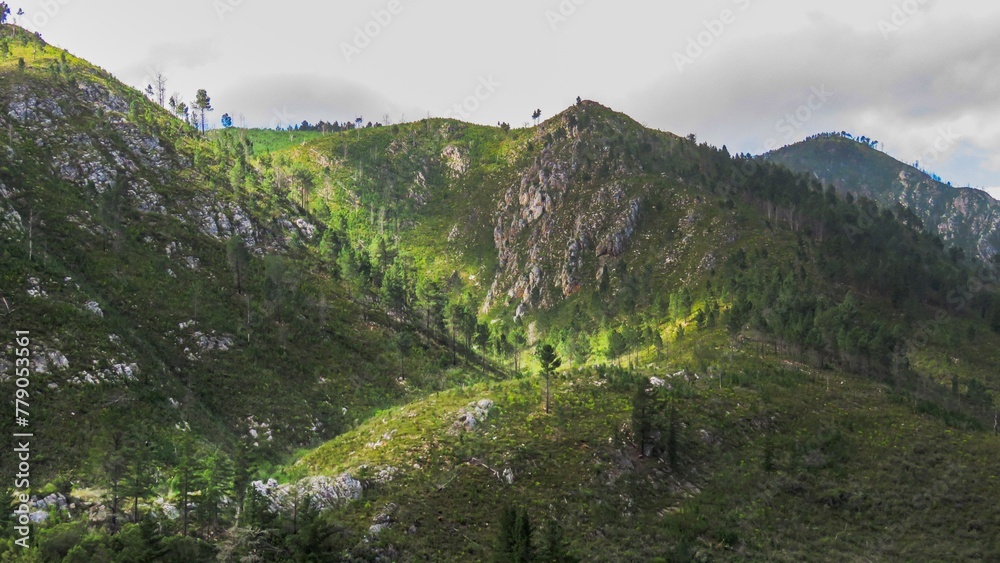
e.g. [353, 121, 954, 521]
[0, 26, 472, 494]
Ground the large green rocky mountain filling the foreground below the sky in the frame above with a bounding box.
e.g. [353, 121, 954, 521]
[0, 26, 1000, 561]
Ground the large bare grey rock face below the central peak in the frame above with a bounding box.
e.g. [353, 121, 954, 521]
[483, 107, 653, 316]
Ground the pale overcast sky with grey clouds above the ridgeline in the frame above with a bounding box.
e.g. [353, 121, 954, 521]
[10, 0, 1000, 196]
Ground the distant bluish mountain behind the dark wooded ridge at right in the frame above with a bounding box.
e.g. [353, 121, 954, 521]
[762, 134, 1000, 261]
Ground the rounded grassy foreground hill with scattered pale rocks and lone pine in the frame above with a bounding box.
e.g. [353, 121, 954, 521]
[299, 328, 1000, 561]
